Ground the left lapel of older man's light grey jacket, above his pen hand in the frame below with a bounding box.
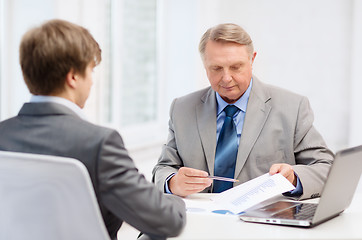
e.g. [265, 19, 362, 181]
[196, 88, 217, 174]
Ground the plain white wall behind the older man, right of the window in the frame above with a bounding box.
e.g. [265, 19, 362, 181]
[164, 0, 362, 151]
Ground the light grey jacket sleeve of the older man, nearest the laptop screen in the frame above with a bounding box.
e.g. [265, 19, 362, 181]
[293, 98, 334, 199]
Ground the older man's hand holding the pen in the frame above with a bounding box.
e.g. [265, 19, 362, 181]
[168, 167, 212, 197]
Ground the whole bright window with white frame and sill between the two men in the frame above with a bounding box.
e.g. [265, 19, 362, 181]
[101, 0, 166, 148]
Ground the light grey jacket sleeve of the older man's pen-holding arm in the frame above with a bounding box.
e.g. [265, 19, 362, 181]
[152, 99, 183, 191]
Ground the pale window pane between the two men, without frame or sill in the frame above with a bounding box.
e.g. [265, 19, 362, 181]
[108, 0, 157, 127]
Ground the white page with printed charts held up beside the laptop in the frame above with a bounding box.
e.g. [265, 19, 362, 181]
[211, 173, 295, 214]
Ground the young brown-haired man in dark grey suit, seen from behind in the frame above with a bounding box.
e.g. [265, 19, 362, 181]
[0, 20, 186, 239]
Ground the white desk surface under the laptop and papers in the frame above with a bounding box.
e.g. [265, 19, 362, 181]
[169, 191, 362, 240]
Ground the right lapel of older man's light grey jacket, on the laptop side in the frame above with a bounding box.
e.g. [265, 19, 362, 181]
[235, 76, 271, 177]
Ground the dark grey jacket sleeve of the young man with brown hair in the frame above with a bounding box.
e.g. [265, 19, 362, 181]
[98, 131, 186, 239]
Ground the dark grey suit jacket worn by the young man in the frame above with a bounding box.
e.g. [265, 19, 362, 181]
[0, 103, 186, 239]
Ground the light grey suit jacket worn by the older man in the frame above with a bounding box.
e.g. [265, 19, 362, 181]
[153, 76, 334, 199]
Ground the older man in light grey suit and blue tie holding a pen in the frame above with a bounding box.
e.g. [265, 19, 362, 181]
[153, 24, 334, 199]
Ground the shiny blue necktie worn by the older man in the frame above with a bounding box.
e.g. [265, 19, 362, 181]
[213, 105, 239, 193]
